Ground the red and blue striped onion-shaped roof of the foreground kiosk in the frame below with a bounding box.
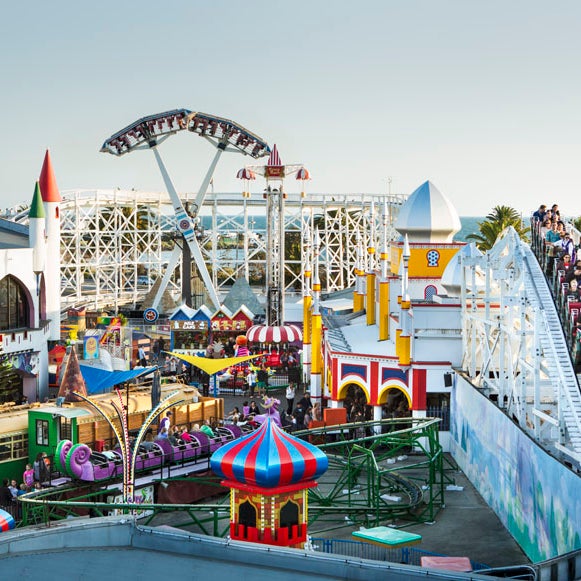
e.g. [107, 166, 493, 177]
[210, 418, 329, 488]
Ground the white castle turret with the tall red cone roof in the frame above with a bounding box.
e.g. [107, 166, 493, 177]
[39, 150, 62, 341]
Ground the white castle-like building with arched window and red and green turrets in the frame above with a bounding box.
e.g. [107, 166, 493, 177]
[0, 151, 60, 404]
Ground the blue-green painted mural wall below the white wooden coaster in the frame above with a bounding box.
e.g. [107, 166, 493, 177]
[450, 376, 581, 562]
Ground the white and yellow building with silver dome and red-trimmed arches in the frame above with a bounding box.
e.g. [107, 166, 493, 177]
[311, 182, 467, 447]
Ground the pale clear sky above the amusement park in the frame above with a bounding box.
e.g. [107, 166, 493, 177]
[0, 0, 581, 216]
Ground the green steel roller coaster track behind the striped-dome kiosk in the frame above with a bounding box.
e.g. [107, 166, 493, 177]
[21, 418, 457, 537]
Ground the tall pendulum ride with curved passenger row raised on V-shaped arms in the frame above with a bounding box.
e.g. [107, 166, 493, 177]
[101, 109, 270, 309]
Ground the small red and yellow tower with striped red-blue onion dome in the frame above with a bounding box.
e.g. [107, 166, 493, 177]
[211, 418, 328, 548]
